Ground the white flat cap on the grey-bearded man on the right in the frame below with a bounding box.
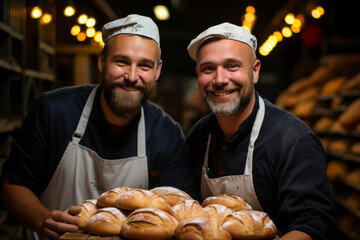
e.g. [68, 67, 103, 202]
[187, 22, 257, 61]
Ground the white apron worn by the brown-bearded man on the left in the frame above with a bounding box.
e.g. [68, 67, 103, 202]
[40, 87, 148, 211]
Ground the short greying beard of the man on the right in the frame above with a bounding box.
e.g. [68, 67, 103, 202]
[205, 84, 254, 117]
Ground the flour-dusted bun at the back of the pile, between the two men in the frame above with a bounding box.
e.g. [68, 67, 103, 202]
[150, 187, 192, 206]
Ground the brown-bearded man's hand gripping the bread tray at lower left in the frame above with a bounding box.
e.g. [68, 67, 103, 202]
[40, 206, 81, 240]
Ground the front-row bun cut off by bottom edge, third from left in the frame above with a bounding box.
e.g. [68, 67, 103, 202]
[175, 218, 231, 240]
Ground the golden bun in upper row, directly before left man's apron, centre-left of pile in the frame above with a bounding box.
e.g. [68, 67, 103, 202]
[115, 189, 171, 213]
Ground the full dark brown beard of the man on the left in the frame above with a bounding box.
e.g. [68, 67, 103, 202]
[102, 74, 156, 118]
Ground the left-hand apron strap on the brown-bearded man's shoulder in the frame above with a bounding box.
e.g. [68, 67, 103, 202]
[72, 85, 99, 143]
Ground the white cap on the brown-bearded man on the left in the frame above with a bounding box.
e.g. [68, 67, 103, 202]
[102, 14, 160, 46]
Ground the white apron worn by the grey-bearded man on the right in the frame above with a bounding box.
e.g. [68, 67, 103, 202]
[201, 96, 265, 211]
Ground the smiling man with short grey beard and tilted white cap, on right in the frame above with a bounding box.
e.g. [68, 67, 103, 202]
[188, 23, 336, 240]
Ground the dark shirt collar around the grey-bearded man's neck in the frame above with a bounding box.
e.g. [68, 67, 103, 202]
[208, 91, 259, 147]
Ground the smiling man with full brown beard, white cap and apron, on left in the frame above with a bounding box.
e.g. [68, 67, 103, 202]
[2, 14, 197, 239]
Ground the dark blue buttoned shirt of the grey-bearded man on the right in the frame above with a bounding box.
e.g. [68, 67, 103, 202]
[188, 93, 336, 240]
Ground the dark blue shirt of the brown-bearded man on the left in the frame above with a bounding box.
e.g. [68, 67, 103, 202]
[3, 85, 197, 200]
